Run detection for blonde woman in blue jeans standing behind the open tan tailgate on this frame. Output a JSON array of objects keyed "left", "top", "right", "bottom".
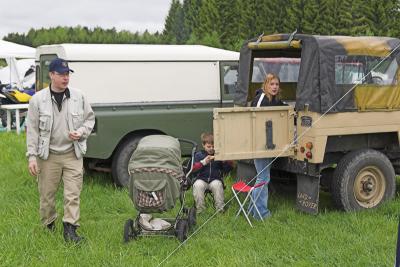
[{"left": 249, "top": 73, "right": 286, "bottom": 220}]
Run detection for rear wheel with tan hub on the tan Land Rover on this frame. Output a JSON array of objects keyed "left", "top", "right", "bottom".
[{"left": 332, "top": 149, "right": 396, "bottom": 211}]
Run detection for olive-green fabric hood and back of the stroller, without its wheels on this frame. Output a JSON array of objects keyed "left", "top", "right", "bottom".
[{"left": 129, "top": 135, "right": 184, "bottom": 212}]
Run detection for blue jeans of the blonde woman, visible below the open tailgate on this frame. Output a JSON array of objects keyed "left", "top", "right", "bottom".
[{"left": 249, "top": 158, "right": 272, "bottom": 220}]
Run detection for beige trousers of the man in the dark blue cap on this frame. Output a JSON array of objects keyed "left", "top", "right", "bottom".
[{"left": 38, "top": 150, "right": 83, "bottom": 225}]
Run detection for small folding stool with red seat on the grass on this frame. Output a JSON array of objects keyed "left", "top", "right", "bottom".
[{"left": 232, "top": 181, "right": 267, "bottom": 227}]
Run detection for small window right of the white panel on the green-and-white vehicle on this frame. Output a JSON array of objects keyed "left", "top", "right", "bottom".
[{"left": 221, "top": 62, "right": 239, "bottom": 100}]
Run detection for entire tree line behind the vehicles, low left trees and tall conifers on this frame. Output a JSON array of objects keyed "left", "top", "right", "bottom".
[{"left": 4, "top": 0, "right": 400, "bottom": 50}]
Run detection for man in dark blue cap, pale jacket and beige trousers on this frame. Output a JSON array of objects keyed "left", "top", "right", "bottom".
[{"left": 26, "top": 58, "right": 94, "bottom": 243}]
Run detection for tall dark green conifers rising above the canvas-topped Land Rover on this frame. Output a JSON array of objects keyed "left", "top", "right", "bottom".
[{"left": 163, "top": 0, "right": 400, "bottom": 50}]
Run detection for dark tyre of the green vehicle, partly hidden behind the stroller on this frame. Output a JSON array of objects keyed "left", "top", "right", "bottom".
[{"left": 111, "top": 136, "right": 143, "bottom": 187}]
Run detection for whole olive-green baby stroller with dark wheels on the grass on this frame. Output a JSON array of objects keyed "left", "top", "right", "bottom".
[{"left": 124, "top": 135, "right": 197, "bottom": 242}]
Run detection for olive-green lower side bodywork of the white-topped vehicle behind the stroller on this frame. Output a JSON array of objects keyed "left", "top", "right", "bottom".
[{"left": 86, "top": 102, "right": 221, "bottom": 159}]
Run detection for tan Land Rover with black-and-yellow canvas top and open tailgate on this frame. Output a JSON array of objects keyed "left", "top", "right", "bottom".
[{"left": 214, "top": 34, "right": 400, "bottom": 214}]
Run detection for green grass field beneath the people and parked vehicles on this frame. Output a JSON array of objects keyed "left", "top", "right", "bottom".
[{"left": 0, "top": 133, "right": 400, "bottom": 266}]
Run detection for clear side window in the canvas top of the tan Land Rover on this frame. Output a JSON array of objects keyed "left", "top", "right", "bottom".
[{"left": 335, "top": 55, "right": 398, "bottom": 85}]
